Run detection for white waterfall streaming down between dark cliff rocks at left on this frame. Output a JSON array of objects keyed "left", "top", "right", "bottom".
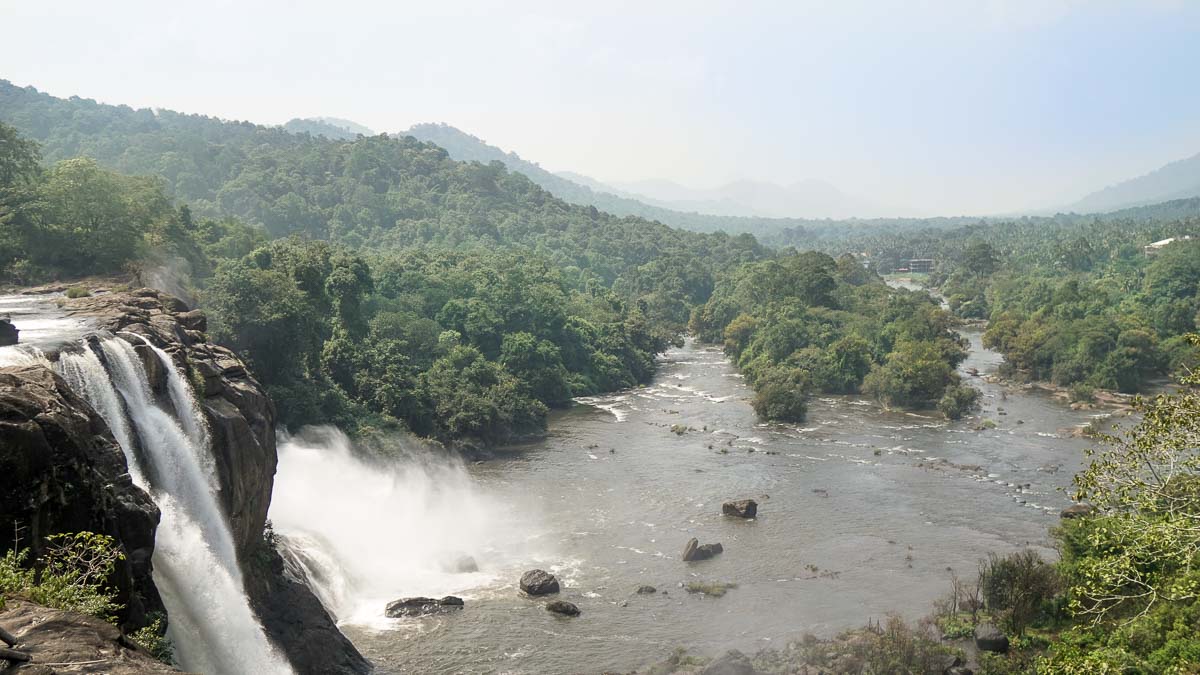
[{"left": 55, "top": 338, "right": 292, "bottom": 675}]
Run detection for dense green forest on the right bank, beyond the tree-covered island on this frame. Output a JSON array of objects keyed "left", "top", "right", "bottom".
[{"left": 825, "top": 211, "right": 1200, "bottom": 399}]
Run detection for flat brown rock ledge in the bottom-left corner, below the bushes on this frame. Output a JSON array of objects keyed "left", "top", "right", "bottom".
[{"left": 0, "top": 599, "right": 179, "bottom": 675}]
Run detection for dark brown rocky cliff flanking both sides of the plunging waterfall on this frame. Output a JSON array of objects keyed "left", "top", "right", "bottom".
[{"left": 0, "top": 288, "right": 370, "bottom": 674}]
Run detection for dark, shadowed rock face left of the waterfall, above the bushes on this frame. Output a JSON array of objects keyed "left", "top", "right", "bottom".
[{"left": 0, "top": 365, "right": 163, "bottom": 629}]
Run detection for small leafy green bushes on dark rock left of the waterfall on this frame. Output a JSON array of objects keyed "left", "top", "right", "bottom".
[{"left": 0, "top": 532, "right": 125, "bottom": 621}]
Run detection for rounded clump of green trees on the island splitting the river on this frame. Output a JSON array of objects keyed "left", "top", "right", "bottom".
[{"left": 691, "top": 252, "right": 978, "bottom": 420}]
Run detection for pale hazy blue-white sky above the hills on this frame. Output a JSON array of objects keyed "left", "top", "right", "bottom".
[{"left": 0, "top": 0, "right": 1200, "bottom": 215}]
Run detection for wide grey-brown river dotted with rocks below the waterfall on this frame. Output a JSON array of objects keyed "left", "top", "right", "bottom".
[{"left": 314, "top": 333, "right": 1108, "bottom": 673}]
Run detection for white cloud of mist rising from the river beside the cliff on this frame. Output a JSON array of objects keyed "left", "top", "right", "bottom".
[{"left": 270, "top": 426, "right": 546, "bottom": 625}]
